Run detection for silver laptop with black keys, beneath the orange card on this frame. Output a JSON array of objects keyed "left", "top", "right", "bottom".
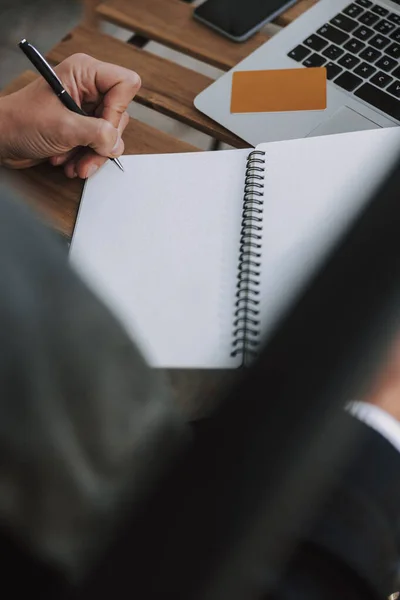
[{"left": 194, "top": 0, "right": 400, "bottom": 146}]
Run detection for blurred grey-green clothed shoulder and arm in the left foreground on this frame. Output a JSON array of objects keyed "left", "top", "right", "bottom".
[{"left": 0, "top": 183, "right": 186, "bottom": 597}]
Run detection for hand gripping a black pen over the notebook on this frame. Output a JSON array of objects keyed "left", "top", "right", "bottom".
[{"left": 0, "top": 54, "right": 141, "bottom": 178}]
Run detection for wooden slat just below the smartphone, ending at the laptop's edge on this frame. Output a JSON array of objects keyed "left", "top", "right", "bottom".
[{"left": 97, "top": 0, "right": 268, "bottom": 70}]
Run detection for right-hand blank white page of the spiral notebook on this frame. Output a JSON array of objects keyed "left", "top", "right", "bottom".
[{"left": 258, "top": 127, "right": 400, "bottom": 342}]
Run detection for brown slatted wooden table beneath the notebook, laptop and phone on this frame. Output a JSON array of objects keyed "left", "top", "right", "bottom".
[{"left": 2, "top": 0, "right": 317, "bottom": 416}]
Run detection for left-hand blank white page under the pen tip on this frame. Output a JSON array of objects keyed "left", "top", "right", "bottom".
[{"left": 71, "top": 150, "right": 248, "bottom": 368}]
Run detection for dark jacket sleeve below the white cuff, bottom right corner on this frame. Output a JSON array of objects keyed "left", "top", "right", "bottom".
[{"left": 271, "top": 417, "right": 400, "bottom": 600}]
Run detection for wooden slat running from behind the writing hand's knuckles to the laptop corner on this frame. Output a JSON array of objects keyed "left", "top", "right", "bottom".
[{"left": 47, "top": 27, "right": 249, "bottom": 148}]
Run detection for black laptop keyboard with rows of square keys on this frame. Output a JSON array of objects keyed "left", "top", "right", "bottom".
[{"left": 288, "top": 0, "right": 400, "bottom": 121}]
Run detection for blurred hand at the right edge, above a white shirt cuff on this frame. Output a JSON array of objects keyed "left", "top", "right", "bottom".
[{"left": 365, "top": 339, "right": 400, "bottom": 421}]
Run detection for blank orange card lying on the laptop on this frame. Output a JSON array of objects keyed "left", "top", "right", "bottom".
[{"left": 231, "top": 67, "right": 326, "bottom": 113}]
